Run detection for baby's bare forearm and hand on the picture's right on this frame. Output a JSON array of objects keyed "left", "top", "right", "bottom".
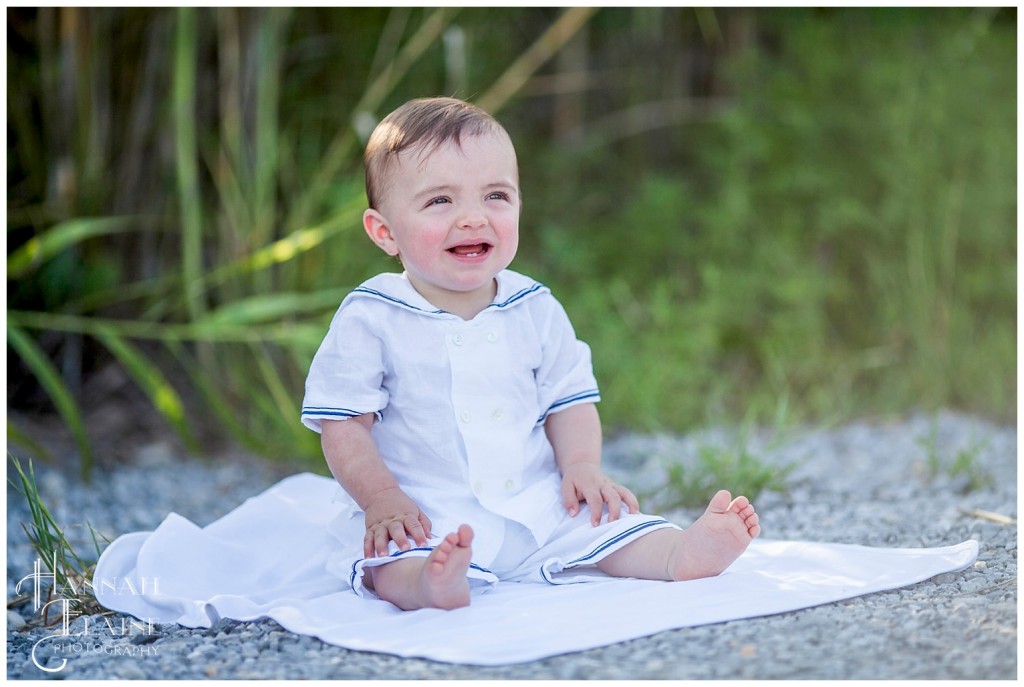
[{"left": 545, "top": 403, "right": 640, "bottom": 525}]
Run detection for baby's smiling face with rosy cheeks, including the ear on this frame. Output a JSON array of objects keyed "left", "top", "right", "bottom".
[{"left": 364, "top": 133, "right": 520, "bottom": 312}]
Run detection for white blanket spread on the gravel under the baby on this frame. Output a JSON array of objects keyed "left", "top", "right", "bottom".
[{"left": 93, "top": 474, "right": 978, "bottom": 665}]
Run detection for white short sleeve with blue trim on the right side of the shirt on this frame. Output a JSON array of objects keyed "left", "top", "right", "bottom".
[{"left": 537, "top": 296, "right": 601, "bottom": 423}]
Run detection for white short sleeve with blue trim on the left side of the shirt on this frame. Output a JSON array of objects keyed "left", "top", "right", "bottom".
[{"left": 302, "top": 301, "right": 388, "bottom": 432}]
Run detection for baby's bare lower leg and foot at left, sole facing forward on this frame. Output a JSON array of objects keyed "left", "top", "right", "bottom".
[{"left": 367, "top": 525, "right": 473, "bottom": 610}]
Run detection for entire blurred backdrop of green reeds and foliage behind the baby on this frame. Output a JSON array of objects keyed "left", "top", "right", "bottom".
[{"left": 7, "top": 8, "right": 1017, "bottom": 475}]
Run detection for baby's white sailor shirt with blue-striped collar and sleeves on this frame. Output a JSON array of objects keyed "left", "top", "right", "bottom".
[{"left": 302, "top": 270, "right": 599, "bottom": 559}]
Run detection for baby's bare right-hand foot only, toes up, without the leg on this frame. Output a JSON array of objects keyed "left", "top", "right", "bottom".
[{"left": 672, "top": 489, "right": 761, "bottom": 581}]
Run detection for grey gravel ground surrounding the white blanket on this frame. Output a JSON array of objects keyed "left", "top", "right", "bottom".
[{"left": 7, "top": 413, "right": 1017, "bottom": 680}]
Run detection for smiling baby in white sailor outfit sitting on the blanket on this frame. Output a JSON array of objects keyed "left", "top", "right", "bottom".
[{"left": 302, "top": 98, "right": 761, "bottom": 609}]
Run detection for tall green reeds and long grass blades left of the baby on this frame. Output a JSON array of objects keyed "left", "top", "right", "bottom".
[{"left": 7, "top": 8, "right": 595, "bottom": 475}]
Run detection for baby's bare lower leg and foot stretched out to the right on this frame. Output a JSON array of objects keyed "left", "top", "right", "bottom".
[{"left": 597, "top": 489, "right": 761, "bottom": 581}]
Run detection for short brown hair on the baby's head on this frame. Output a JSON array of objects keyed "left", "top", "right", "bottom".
[{"left": 362, "top": 97, "right": 508, "bottom": 209}]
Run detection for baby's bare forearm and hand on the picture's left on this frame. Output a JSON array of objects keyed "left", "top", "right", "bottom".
[{"left": 321, "top": 413, "right": 430, "bottom": 558}]
